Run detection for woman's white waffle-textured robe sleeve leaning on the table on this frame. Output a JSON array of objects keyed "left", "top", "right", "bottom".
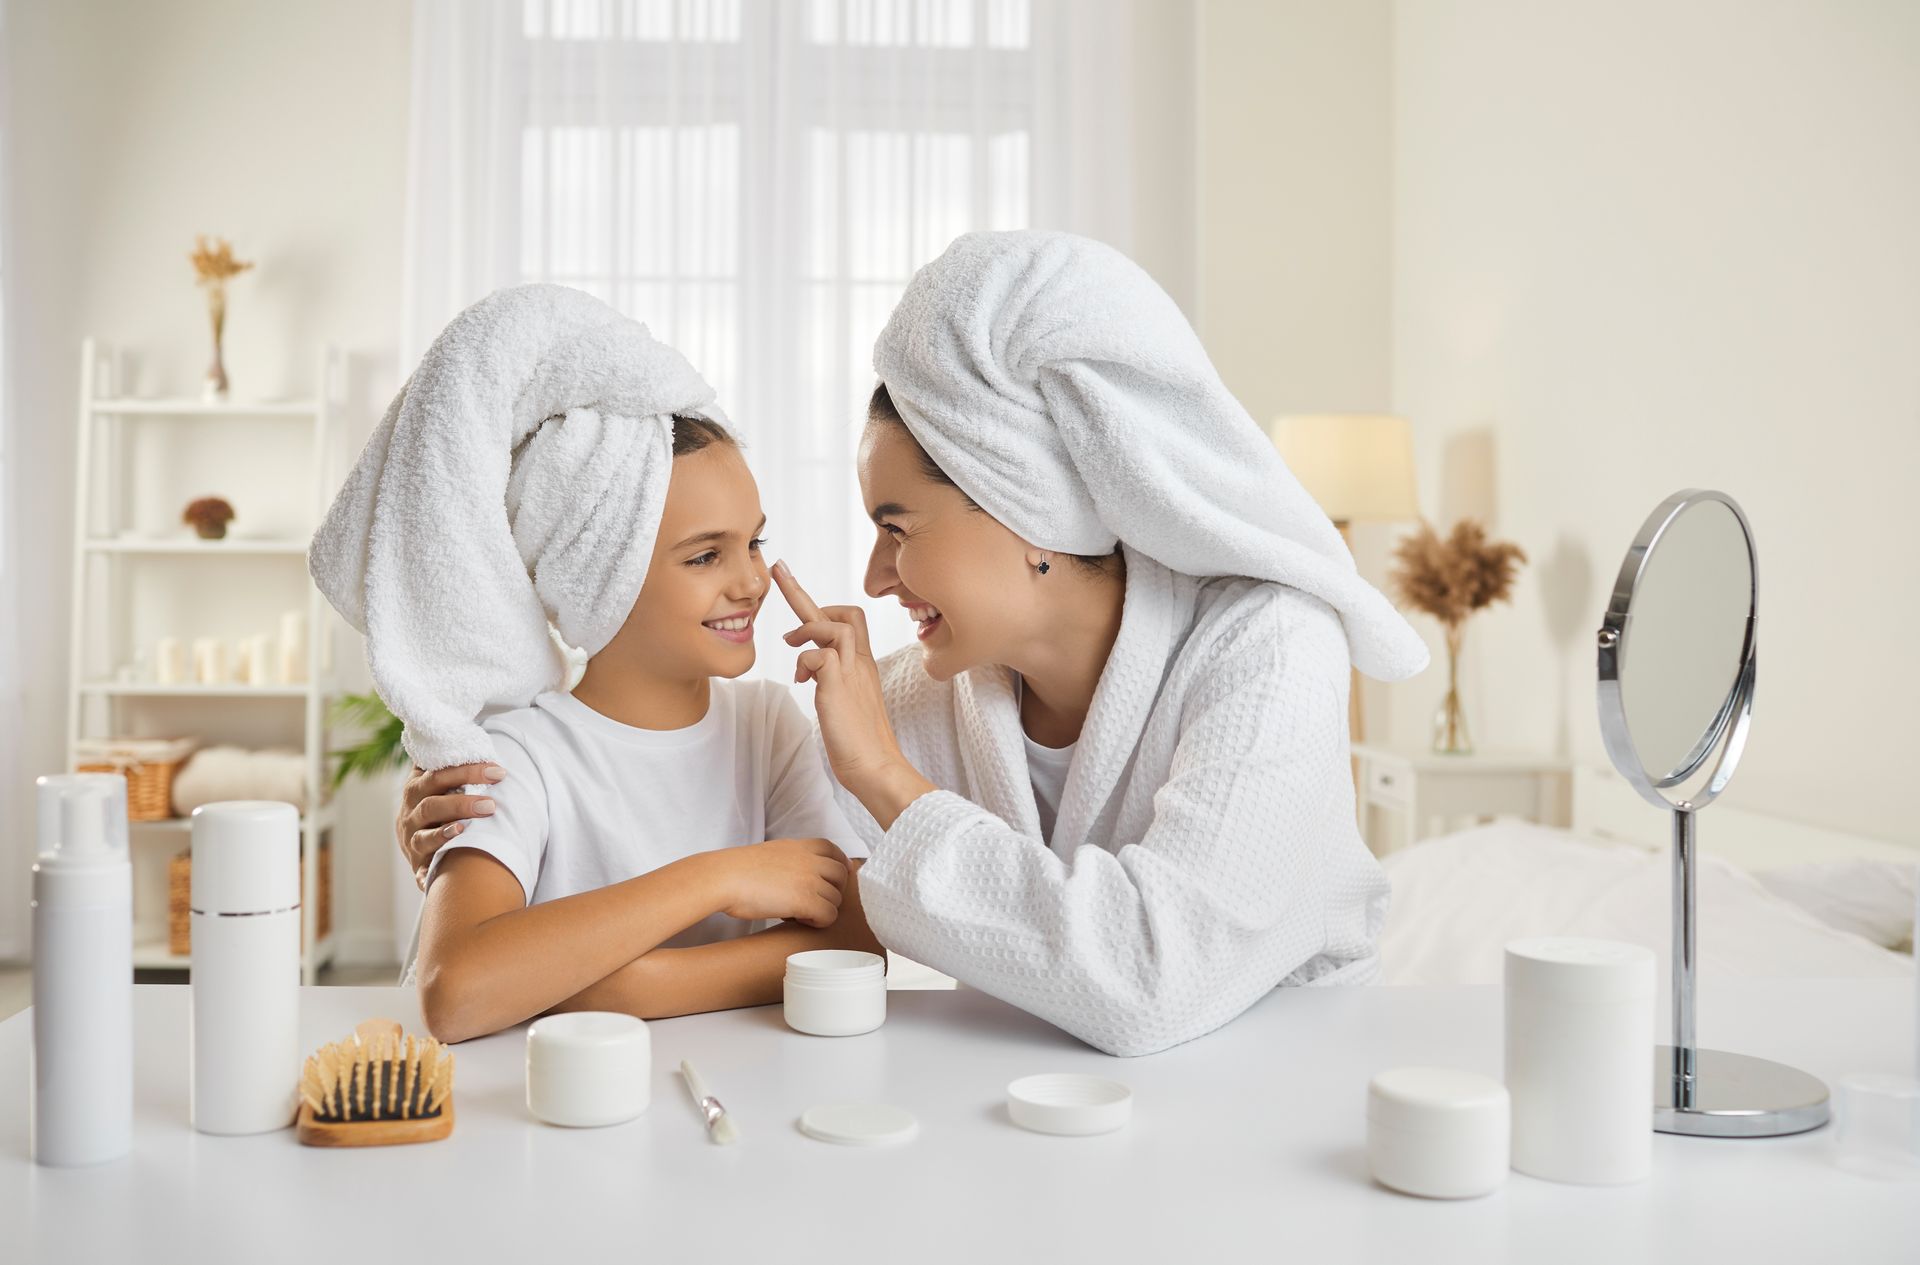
[{"left": 856, "top": 603, "right": 1386, "bottom": 1056}]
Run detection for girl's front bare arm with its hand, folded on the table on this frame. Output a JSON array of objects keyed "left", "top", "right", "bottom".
[{"left": 419, "top": 839, "right": 847, "bottom": 1040}]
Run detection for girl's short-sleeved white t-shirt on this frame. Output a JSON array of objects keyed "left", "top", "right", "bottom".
[{"left": 426, "top": 680, "right": 866, "bottom": 946}]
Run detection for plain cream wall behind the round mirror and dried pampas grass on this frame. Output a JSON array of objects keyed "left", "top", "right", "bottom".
[{"left": 1392, "top": 0, "right": 1920, "bottom": 841}]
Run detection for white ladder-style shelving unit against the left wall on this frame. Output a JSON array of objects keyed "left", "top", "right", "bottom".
[{"left": 67, "top": 340, "right": 342, "bottom": 985}]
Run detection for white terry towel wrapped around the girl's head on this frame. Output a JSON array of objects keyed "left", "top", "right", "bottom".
[{"left": 307, "top": 284, "right": 726, "bottom": 768}]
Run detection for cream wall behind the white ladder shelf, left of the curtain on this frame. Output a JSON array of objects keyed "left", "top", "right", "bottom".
[{"left": 0, "top": 0, "right": 411, "bottom": 958}]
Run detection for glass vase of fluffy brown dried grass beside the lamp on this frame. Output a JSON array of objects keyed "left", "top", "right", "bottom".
[{"left": 1390, "top": 518, "right": 1526, "bottom": 754}]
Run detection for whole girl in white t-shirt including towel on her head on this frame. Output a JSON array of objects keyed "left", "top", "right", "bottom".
[{"left": 311, "top": 286, "right": 877, "bottom": 1040}]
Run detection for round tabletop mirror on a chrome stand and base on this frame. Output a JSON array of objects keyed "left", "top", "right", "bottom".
[{"left": 1599, "top": 489, "right": 1828, "bottom": 1138}]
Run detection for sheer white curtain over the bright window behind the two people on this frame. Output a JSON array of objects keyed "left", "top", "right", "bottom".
[{"left": 401, "top": 0, "right": 1131, "bottom": 678}]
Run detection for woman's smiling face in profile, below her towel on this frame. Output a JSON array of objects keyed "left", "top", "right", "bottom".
[{"left": 860, "top": 418, "right": 1031, "bottom": 681}]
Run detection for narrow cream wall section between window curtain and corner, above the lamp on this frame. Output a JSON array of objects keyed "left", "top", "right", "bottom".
[{"left": 1194, "top": 0, "right": 1392, "bottom": 422}]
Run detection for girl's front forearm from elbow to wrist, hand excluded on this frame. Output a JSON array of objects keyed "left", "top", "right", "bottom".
[{"left": 419, "top": 848, "right": 726, "bottom": 1040}]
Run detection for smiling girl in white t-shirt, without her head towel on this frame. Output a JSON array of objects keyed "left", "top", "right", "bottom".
[{"left": 419, "top": 418, "right": 879, "bottom": 1040}]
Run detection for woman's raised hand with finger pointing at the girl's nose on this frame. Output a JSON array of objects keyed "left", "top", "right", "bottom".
[{"left": 774, "top": 562, "right": 933, "bottom": 829}]
